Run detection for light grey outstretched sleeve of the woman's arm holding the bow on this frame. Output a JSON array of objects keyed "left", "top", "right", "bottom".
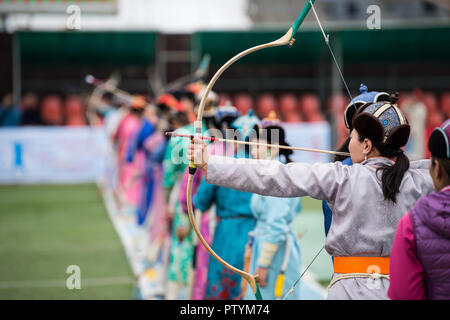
[{"left": 206, "top": 156, "right": 353, "bottom": 203}]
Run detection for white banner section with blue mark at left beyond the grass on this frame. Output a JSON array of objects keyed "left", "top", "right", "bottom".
[{"left": 0, "top": 127, "right": 108, "bottom": 184}]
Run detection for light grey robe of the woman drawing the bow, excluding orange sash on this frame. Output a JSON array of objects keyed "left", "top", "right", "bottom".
[{"left": 206, "top": 156, "right": 434, "bottom": 299}]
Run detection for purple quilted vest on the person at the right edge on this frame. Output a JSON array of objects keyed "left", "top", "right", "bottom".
[{"left": 410, "top": 187, "right": 450, "bottom": 300}]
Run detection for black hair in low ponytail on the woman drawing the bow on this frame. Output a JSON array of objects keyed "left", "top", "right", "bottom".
[{"left": 359, "top": 136, "right": 409, "bottom": 203}]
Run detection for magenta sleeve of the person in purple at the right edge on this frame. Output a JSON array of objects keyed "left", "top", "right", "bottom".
[{"left": 388, "top": 213, "right": 426, "bottom": 300}]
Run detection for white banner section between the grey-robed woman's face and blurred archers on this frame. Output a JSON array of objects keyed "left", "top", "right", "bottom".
[{"left": 283, "top": 121, "right": 332, "bottom": 163}]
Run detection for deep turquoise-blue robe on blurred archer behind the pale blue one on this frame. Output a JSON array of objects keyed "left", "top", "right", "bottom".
[{"left": 193, "top": 152, "right": 256, "bottom": 300}]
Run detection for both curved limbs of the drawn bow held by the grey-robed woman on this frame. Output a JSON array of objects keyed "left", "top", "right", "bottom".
[{"left": 186, "top": 0, "right": 315, "bottom": 300}]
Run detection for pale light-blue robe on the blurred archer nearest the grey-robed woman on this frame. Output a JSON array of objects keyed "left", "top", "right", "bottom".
[{"left": 244, "top": 194, "right": 301, "bottom": 300}]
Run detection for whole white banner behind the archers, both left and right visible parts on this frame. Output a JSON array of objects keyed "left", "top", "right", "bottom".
[{"left": 0, "top": 122, "right": 331, "bottom": 184}]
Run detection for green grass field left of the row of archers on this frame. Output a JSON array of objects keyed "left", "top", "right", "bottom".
[{"left": 0, "top": 184, "right": 134, "bottom": 299}]
